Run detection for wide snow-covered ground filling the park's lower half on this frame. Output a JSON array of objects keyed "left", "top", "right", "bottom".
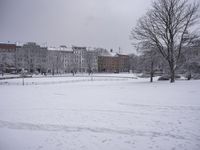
[{"left": 0, "top": 75, "right": 200, "bottom": 150}]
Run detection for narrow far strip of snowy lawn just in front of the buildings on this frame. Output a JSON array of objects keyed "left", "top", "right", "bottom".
[{"left": 0, "top": 73, "right": 136, "bottom": 85}]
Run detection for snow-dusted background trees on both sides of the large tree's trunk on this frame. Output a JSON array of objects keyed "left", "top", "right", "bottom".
[{"left": 130, "top": 40, "right": 200, "bottom": 82}]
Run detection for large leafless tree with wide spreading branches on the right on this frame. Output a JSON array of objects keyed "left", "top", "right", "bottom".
[{"left": 131, "top": 0, "right": 199, "bottom": 82}]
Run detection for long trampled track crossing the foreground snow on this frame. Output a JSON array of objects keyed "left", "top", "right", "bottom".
[{"left": 0, "top": 120, "right": 185, "bottom": 140}]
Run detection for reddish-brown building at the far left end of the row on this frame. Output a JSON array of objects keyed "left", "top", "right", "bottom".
[{"left": 0, "top": 43, "right": 16, "bottom": 73}]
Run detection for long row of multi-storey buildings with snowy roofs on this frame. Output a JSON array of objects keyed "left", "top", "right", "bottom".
[{"left": 0, "top": 42, "right": 129, "bottom": 74}]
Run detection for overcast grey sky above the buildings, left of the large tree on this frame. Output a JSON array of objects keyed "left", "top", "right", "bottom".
[{"left": 0, "top": 0, "right": 156, "bottom": 53}]
